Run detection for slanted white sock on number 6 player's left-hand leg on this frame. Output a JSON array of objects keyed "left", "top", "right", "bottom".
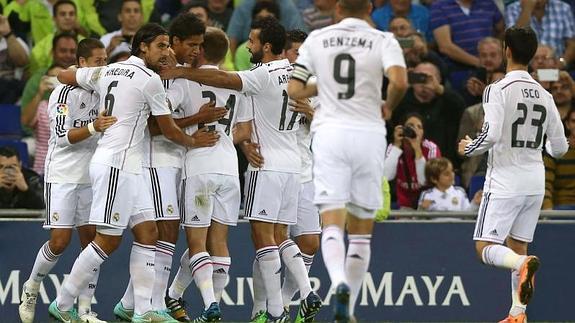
[{"left": 56, "top": 241, "right": 108, "bottom": 311}]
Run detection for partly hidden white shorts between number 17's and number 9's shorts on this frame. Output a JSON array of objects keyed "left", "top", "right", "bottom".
[{"left": 290, "top": 181, "right": 321, "bottom": 237}]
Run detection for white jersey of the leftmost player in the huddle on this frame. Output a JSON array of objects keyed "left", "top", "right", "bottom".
[{"left": 44, "top": 85, "right": 100, "bottom": 184}]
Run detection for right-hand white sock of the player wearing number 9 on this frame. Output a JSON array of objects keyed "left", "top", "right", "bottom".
[{"left": 345, "top": 234, "right": 371, "bottom": 315}]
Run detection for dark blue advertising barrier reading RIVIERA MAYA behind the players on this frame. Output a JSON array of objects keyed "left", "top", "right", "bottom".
[{"left": 0, "top": 212, "right": 575, "bottom": 322}]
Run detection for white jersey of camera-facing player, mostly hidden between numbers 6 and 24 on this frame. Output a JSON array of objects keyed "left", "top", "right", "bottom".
[{"left": 143, "top": 80, "right": 186, "bottom": 168}]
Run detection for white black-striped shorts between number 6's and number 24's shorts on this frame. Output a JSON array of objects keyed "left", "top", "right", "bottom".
[{"left": 144, "top": 167, "right": 181, "bottom": 221}]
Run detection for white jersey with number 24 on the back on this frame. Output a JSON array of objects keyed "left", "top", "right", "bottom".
[{"left": 168, "top": 65, "right": 252, "bottom": 178}]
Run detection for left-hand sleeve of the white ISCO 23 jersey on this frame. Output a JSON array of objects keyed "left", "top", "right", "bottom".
[{"left": 465, "top": 84, "right": 505, "bottom": 157}]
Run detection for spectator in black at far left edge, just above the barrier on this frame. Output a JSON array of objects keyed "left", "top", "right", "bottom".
[{"left": 0, "top": 147, "right": 44, "bottom": 209}]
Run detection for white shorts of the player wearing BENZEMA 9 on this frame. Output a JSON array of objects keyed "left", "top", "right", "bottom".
[{"left": 312, "top": 126, "right": 386, "bottom": 216}]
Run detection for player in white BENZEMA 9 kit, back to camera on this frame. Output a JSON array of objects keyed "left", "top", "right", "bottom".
[{"left": 288, "top": 0, "right": 407, "bottom": 322}]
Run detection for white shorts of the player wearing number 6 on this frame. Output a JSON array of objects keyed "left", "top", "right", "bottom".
[{"left": 90, "top": 163, "right": 154, "bottom": 229}]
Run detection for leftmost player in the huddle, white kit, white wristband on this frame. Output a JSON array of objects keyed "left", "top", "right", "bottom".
[{"left": 18, "top": 39, "right": 112, "bottom": 323}]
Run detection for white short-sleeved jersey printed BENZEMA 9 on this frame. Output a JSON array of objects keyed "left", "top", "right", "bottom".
[{"left": 293, "top": 18, "right": 405, "bottom": 132}]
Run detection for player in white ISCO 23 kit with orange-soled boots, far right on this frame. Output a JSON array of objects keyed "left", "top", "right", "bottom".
[{"left": 459, "top": 27, "right": 569, "bottom": 323}]
